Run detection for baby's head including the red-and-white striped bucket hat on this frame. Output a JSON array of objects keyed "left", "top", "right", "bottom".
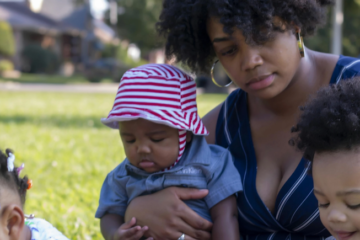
[{"left": 102, "top": 64, "right": 208, "bottom": 172}]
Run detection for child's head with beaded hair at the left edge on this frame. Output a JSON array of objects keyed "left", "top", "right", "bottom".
[{"left": 0, "top": 149, "right": 28, "bottom": 240}]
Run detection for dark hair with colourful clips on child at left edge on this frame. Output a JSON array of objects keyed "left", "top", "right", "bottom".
[{"left": 0, "top": 149, "right": 28, "bottom": 206}]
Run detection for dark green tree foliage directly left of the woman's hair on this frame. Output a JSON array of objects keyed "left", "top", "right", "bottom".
[{"left": 112, "top": 0, "right": 162, "bottom": 55}]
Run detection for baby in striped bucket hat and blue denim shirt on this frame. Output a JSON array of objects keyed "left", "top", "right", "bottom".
[{"left": 95, "top": 64, "right": 242, "bottom": 240}]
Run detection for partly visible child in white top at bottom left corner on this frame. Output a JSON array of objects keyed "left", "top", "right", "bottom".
[{"left": 0, "top": 149, "right": 68, "bottom": 240}]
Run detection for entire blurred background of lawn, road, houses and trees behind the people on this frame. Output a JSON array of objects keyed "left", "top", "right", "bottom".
[{"left": 0, "top": 0, "right": 360, "bottom": 240}]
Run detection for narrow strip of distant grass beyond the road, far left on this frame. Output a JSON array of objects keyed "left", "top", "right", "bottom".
[{"left": 0, "top": 73, "right": 89, "bottom": 84}]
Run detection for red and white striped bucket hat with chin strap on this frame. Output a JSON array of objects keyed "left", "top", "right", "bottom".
[{"left": 101, "top": 64, "right": 208, "bottom": 170}]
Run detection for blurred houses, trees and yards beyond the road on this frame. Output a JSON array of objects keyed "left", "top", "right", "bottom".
[{"left": 0, "top": 0, "right": 360, "bottom": 90}]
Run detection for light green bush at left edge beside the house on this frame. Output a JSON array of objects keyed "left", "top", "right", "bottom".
[{"left": 0, "top": 21, "right": 15, "bottom": 56}]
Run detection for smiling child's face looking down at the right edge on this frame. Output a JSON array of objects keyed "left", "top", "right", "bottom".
[{"left": 313, "top": 150, "right": 360, "bottom": 240}]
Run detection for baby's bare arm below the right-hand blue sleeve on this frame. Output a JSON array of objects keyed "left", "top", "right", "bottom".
[{"left": 210, "top": 195, "right": 240, "bottom": 240}]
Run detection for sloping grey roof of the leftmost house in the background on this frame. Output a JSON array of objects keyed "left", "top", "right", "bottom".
[{"left": 0, "top": 2, "right": 79, "bottom": 34}]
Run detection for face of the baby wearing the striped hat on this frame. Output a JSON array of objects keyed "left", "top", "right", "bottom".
[{"left": 119, "top": 119, "right": 179, "bottom": 173}]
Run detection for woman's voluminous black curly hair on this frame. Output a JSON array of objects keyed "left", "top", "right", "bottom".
[{"left": 157, "top": 0, "right": 334, "bottom": 72}]
